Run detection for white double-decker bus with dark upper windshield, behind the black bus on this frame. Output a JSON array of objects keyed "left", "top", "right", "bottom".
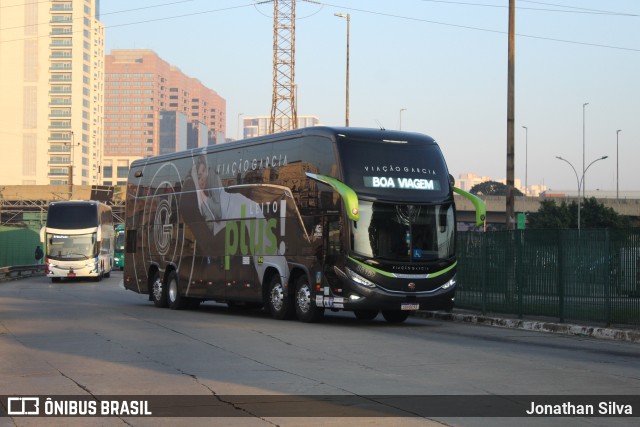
[{"left": 40, "top": 201, "right": 115, "bottom": 282}]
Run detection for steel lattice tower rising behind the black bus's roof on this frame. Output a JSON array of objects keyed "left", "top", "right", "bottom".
[{"left": 269, "top": 0, "right": 298, "bottom": 133}]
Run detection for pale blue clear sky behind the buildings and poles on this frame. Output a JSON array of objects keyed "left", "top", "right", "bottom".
[{"left": 100, "top": 0, "right": 640, "bottom": 192}]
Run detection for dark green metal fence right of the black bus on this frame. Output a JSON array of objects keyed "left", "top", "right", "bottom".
[{"left": 456, "top": 229, "right": 640, "bottom": 326}]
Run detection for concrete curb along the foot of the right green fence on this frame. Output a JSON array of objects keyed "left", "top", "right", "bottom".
[{"left": 414, "top": 311, "right": 640, "bottom": 342}]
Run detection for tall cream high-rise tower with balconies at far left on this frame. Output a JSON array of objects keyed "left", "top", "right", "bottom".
[{"left": 0, "top": 0, "right": 104, "bottom": 185}]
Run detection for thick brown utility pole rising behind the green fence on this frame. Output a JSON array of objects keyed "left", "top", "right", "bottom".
[{"left": 505, "top": 0, "right": 516, "bottom": 230}]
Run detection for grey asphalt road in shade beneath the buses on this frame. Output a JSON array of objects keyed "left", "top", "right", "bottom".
[{"left": 0, "top": 272, "right": 640, "bottom": 426}]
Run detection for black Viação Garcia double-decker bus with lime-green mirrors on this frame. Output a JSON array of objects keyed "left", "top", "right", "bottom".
[{"left": 124, "top": 127, "right": 484, "bottom": 322}]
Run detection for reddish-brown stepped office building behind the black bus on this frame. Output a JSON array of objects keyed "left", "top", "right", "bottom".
[{"left": 103, "top": 49, "right": 226, "bottom": 185}]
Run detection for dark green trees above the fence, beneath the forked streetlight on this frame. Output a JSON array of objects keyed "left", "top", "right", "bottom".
[{"left": 527, "top": 197, "right": 629, "bottom": 228}]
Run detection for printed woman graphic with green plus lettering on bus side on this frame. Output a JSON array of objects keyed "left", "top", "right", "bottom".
[{"left": 181, "top": 150, "right": 292, "bottom": 286}]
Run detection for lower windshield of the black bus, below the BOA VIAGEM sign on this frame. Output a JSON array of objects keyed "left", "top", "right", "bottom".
[{"left": 352, "top": 200, "right": 455, "bottom": 262}]
